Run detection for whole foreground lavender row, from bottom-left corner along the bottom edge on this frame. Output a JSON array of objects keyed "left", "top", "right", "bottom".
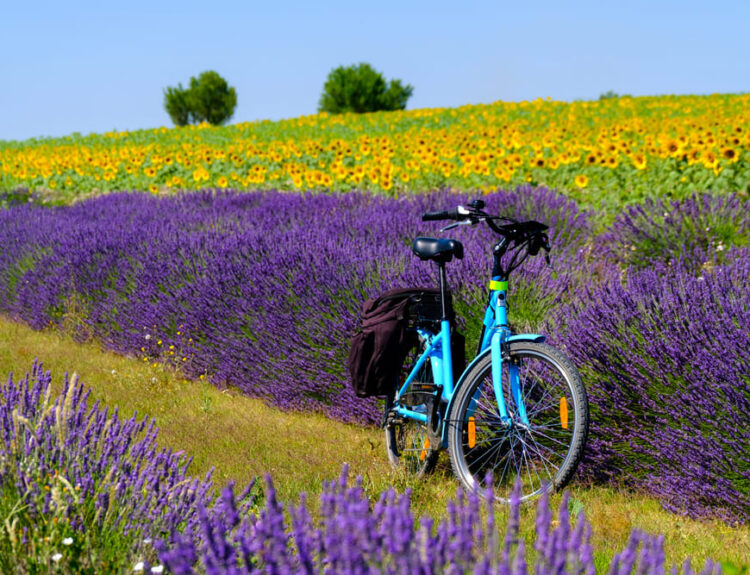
[{"left": 0, "top": 365, "right": 721, "bottom": 575}]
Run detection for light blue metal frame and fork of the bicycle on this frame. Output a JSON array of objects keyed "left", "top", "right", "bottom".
[{"left": 394, "top": 276, "right": 545, "bottom": 447}]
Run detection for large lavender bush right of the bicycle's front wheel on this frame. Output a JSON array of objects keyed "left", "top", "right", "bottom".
[{"left": 558, "top": 249, "right": 750, "bottom": 523}]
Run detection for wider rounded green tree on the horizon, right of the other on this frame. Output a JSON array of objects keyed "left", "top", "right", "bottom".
[{"left": 318, "top": 63, "right": 414, "bottom": 114}]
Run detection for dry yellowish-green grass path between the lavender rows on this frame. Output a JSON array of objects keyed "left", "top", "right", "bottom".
[{"left": 0, "top": 317, "right": 750, "bottom": 574}]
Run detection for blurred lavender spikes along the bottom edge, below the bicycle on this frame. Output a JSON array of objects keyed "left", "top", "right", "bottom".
[{"left": 156, "top": 469, "right": 721, "bottom": 575}]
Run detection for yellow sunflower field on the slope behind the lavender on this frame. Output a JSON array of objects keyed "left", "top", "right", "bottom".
[{"left": 0, "top": 94, "right": 750, "bottom": 205}]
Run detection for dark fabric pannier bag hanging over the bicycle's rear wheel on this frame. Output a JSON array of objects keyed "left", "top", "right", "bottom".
[{"left": 349, "top": 288, "right": 465, "bottom": 397}]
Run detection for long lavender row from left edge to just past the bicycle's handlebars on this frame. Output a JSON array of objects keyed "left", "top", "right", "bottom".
[{"left": 0, "top": 188, "right": 588, "bottom": 422}]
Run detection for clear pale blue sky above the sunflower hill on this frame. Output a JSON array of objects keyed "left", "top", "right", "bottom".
[{"left": 0, "top": 0, "right": 750, "bottom": 140}]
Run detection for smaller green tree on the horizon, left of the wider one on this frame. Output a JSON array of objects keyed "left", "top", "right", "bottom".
[{"left": 164, "top": 70, "right": 237, "bottom": 126}]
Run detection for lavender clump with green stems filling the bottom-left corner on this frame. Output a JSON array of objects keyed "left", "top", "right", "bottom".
[{"left": 0, "top": 364, "right": 229, "bottom": 573}]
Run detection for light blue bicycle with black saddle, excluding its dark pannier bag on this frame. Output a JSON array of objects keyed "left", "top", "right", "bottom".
[{"left": 383, "top": 200, "right": 589, "bottom": 501}]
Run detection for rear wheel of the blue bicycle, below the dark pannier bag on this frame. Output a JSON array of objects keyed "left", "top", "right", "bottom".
[{"left": 385, "top": 338, "right": 441, "bottom": 477}]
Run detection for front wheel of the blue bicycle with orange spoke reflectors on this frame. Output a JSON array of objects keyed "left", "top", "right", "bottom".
[{"left": 448, "top": 342, "right": 589, "bottom": 501}]
